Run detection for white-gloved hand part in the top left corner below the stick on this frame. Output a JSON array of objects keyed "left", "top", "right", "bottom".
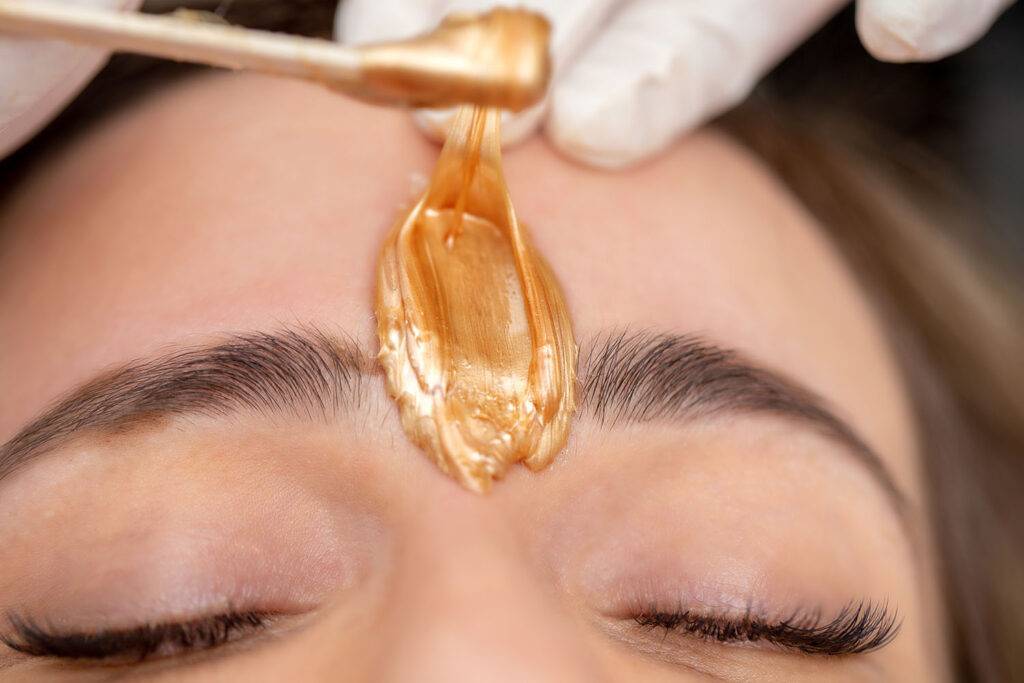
[{"left": 0, "top": 0, "right": 142, "bottom": 159}]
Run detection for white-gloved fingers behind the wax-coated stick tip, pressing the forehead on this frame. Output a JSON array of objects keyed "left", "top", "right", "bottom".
[{"left": 335, "top": 0, "right": 1013, "bottom": 168}]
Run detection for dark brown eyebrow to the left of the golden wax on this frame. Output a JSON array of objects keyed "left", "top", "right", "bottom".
[{"left": 0, "top": 329, "right": 370, "bottom": 480}]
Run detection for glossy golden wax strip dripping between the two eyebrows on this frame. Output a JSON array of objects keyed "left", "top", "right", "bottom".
[{"left": 377, "top": 106, "right": 577, "bottom": 493}]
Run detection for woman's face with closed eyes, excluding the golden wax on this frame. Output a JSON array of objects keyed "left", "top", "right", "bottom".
[{"left": 0, "top": 75, "right": 945, "bottom": 681}]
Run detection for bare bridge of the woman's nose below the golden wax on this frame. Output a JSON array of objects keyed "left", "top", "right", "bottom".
[{"left": 376, "top": 492, "right": 600, "bottom": 683}]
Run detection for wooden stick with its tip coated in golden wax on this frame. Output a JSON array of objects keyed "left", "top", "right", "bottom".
[{"left": 0, "top": 0, "right": 549, "bottom": 110}]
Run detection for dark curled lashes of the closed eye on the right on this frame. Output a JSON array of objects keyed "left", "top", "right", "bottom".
[{"left": 632, "top": 602, "right": 900, "bottom": 656}]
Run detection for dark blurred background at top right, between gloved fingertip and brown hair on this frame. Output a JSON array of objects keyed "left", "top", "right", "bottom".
[{"left": 763, "top": 2, "right": 1024, "bottom": 267}]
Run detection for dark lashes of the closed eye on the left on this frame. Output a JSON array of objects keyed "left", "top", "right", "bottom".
[{"left": 0, "top": 611, "right": 270, "bottom": 661}]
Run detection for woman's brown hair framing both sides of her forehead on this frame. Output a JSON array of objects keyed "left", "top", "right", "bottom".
[{"left": 0, "top": 0, "right": 1024, "bottom": 683}]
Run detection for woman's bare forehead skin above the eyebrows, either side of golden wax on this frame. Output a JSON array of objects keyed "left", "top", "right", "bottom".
[{"left": 0, "top": 75, "right": 912, "bottom": 491}]
